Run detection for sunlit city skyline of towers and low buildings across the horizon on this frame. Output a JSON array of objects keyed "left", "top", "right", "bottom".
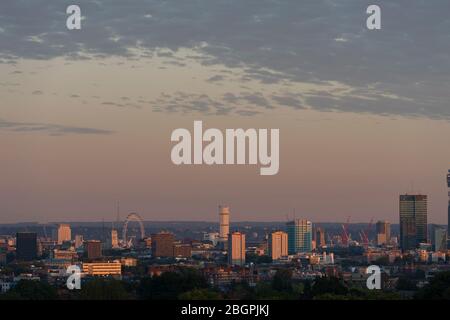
[{"left": 0, "top": 185, "right": 450, "bottom": 300}]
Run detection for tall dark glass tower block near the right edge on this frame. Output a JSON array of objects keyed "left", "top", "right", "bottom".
[{"left": 400, "top": 195, "right": 428, "bottom": 251}]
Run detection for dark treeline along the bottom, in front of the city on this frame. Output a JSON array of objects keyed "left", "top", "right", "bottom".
[{"left": 0, "top": 269, "right": 450, "bottom": 300}]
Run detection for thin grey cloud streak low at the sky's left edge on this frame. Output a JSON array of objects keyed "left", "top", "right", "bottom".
[{"left": 0, "top": 119, "right": 114, "bottom": 136}]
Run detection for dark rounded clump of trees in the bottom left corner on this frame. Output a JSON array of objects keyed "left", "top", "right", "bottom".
[{"left": 0, "top": 280, "right": 58, "bottom": 300}]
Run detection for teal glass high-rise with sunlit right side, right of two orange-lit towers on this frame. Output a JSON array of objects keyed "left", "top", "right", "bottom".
[{"left": 286, "top": 219, "right": 312, "bottom": 254}]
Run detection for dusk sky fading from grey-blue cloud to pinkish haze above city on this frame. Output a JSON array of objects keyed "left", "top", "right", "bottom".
[{"left": 0, "top": 0, "right": 450, "bottom": 224}]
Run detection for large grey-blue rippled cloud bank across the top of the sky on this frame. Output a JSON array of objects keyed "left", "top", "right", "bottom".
[{"left": 0, "top": 0, "right": 450, "bottom": 119}]
